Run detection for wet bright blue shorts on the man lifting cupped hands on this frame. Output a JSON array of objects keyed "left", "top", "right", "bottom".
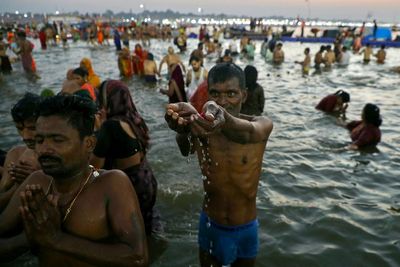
[{"left": 198, "top": 212, "right": 259, "bottom": 265}]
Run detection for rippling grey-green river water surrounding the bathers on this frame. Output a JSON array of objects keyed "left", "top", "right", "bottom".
[{"left": 0, "top": 36, "right": 400, "bottom": 267}]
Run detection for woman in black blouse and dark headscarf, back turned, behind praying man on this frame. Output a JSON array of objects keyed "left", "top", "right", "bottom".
[{"left": 91, "top": 80, "right": 157, "bottom": 234}]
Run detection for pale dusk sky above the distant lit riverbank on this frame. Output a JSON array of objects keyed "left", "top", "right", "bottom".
[{"left": 0, "top": 0, "right": 400, "bottom": 23}]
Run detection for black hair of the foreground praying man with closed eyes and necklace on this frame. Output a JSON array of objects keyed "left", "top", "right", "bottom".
[{"left": 39, "top": 95, "right": 96, "bottom": 140}]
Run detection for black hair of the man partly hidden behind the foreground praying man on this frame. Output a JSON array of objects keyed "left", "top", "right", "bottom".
[{"left": 11, "top": 93, "right": 41, "bottom": 122}]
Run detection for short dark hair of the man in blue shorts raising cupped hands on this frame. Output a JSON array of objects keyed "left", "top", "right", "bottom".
[{"left": 207, "top": 63, "right": 246, "bottom": 90}]
